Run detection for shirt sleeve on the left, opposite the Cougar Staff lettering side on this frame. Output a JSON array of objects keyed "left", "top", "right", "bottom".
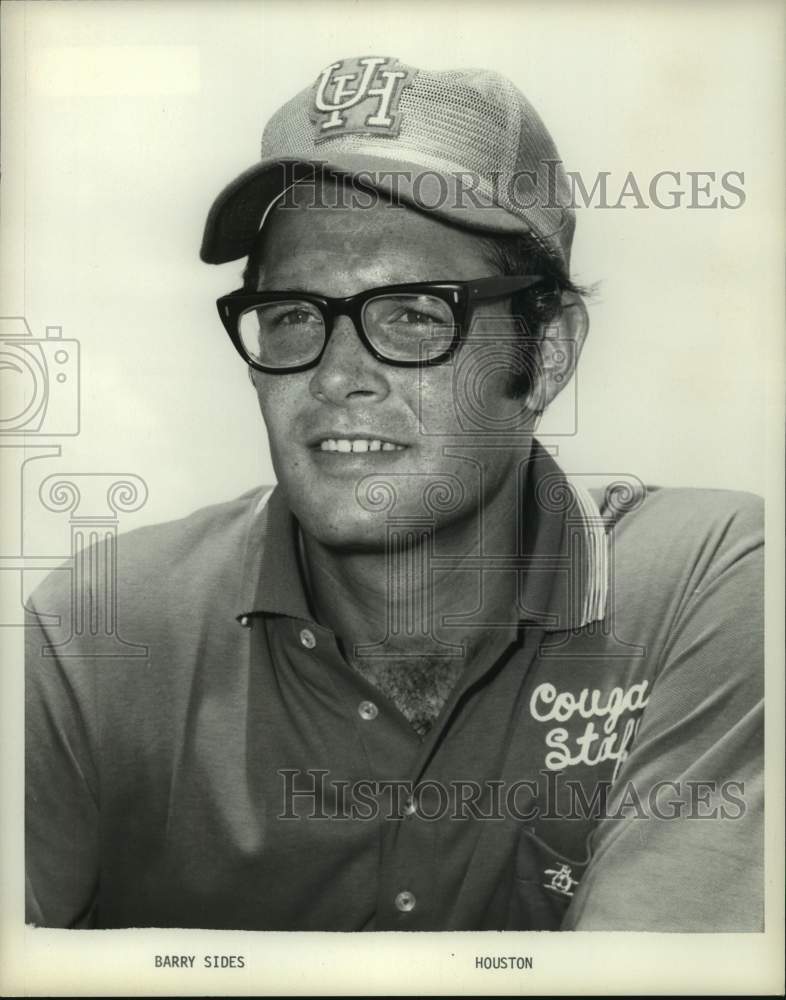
[{"left": 25, "top": 584, "right": 98, "bottom": 927}]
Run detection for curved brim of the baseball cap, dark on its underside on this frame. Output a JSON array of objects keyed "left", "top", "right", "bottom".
[{"left": 200, "top": 153, "right": 530, "bottom": 264}]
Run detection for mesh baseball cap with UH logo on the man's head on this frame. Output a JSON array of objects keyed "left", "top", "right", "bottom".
[{"left": 200, "top": 56, "right": 575, "bottom": 270}]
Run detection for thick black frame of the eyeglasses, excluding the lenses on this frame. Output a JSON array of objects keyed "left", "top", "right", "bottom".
[{"left": 216, "top": 274, "right": 556, "bottom": 375}]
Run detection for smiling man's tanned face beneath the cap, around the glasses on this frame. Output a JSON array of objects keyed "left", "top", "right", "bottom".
[{"left": 248, "top": 184, "right": 531, "bottom": 549}]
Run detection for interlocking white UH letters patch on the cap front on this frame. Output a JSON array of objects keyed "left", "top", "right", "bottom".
[{"left": 310, "top": 56, "right": 417, "bottom": 142}]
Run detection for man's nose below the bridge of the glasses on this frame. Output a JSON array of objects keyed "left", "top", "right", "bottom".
[{"left": 310, "top": 316, "right": 390, "bottom": 405}]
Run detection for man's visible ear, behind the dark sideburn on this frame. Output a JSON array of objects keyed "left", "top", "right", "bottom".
[{"left": 530, "top": 292, "right": 589, "bottom": 413}]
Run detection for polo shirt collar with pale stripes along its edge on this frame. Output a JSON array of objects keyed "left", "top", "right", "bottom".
[{"left": 236, "top": 441, "right": 608, "bottom": 631}]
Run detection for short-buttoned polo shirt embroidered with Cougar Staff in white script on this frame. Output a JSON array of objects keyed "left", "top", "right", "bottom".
[{"left": 26, "top": 448, "right": 763, "bottom": 931}]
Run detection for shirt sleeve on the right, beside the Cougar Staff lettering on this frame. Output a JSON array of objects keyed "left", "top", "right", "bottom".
[{"left": 562, "top": 498, "right": 764, "bottom": 932}]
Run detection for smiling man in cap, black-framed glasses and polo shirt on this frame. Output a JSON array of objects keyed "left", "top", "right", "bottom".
[{"left": 27, "top": 56, "right": 763, "bottom": 931}]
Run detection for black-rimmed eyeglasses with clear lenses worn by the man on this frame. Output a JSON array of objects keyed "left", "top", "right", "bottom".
[{"left": 216, "top": 275, "right": 546, "bottom": 374}]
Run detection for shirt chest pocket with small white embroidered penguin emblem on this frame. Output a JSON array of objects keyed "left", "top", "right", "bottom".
[{"left": 509, "top": 829, "right": 590, "bottom": 931}]
